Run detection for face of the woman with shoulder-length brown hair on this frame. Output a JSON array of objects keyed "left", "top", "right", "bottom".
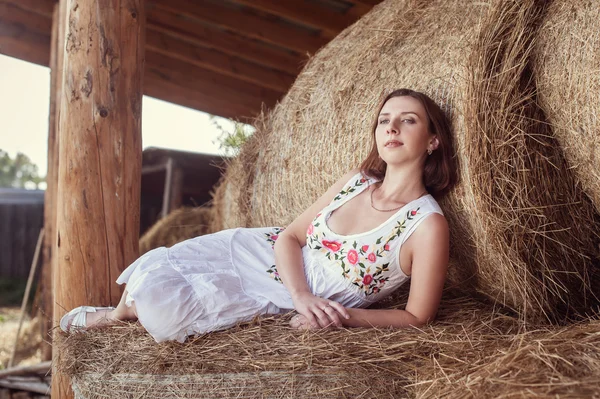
[{"left": 375, "top": 96, "right": 438, "bottom": 165}]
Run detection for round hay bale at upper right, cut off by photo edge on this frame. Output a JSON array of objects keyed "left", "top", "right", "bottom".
[{"left": 534, "top": 0, "right": 600, "bottom": 216}]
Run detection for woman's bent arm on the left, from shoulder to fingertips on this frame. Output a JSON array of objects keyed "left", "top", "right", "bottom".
[{"left": 274, "top": 168, "right": 360, "bottom": 328}]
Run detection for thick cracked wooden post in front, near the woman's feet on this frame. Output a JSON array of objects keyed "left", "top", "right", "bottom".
[{"left": 52, "top": 0, "right": 145, "bottom": 399}]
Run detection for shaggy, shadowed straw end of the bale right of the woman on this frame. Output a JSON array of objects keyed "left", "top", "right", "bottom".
[{"left": 459, "top": 0, "right": 600, "bottom": 323}]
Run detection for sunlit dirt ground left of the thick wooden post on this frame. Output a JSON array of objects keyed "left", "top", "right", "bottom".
[{"left": 0, "top": 307, "right": 42, "bottom": 370}]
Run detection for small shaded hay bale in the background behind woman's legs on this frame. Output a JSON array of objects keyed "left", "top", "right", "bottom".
[{"left": 140, "top": 206, "right": 212, "bottom": 255}]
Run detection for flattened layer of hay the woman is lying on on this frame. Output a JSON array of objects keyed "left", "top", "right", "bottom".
[{"left": 55, "top": 292, "right": 600, "bottom": 399}]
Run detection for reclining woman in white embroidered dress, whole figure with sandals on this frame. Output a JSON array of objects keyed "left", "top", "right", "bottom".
[{"left": 60, "top": 89, "right": 457, "bottom": 342}]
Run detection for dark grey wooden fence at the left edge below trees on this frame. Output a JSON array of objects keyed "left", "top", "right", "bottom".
[{"left": 0, "top": 188, "right": 44, "bottom": 280}]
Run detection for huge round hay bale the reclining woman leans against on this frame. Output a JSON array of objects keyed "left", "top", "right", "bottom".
[{"left": 249, "top": 0, "right": 600, "bottom": 322}]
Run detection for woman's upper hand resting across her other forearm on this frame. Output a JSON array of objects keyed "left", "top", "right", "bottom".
[{"left": 292, "top": 292, "right": 350, "bottom": 328}]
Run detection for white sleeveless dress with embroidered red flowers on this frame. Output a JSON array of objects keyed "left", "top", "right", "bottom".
[{"left": 117, "top": 173, "right": 443, "bottom": 342}]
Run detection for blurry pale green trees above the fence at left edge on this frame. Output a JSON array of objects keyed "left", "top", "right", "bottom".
[{"left": 0, "top": 149, "right": 45, "bottom": 188}]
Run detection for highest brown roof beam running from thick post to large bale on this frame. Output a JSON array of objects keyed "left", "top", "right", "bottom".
[{"left": 148, "top": 8, "right": 307, "bottom": 75}]
